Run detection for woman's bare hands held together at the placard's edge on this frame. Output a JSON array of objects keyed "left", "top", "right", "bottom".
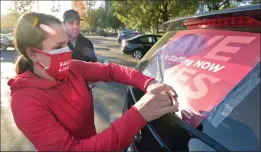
[{"left": 134, "top": 84, "right": 179, "bottom": 122}]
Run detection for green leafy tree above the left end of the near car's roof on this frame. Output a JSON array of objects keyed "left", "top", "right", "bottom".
[{"left": 112, "top": 0, "right": 198, "bottom": 33}]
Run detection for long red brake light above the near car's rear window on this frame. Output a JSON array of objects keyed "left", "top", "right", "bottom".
[{"left": 184, "top": 16, "right": 261, "bottom": 29}]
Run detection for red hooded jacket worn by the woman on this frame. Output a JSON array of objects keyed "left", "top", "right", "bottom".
[{"left": 8, "top": 60, "right": 152, "bottom": 151}]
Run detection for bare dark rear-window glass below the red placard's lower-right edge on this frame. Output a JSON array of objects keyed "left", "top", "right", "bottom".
[{"left": 199, "top": 68, "right": 260, "bottom": 151}]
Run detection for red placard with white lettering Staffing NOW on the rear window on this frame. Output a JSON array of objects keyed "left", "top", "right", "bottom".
[{"left": 145, "top": 30, "right": 260, "bottom": 127}]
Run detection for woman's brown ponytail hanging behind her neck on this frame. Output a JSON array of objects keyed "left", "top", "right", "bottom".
[{"left": 15, "top": 55, "right": 33, "bottom": 75}]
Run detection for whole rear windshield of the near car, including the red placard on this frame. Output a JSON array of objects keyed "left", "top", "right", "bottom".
[{"left": 138, "top": 29, "right": 260, "bottom": 151}]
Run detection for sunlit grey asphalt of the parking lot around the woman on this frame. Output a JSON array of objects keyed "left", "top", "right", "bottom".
[{"left": 1, "top": 36, "right": 137, "bottom": 151}]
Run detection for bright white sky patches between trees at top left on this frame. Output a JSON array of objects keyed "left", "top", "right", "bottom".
[{"left": 1, "top": 0, "right": 102, "bottom": 20}]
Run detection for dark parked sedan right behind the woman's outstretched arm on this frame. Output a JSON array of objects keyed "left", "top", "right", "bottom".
[{"left": 121, "top": 34, "right": 161, "bottom": 59}]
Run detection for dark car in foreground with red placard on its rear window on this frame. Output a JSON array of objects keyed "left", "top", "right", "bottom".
[{"left": 123, "top": 4, "right": 261, "bottom": 152}]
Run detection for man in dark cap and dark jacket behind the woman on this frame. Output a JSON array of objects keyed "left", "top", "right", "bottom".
[{"left": 63, "top": 10, "right": 97, "bottom": 62}]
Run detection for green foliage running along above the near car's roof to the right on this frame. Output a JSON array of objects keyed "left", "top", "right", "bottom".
[{"left": 112, "top": 0, "right": 251, "bottom": 33}]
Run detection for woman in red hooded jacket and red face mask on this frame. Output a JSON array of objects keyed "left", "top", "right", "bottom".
[{"left": 8, "top": 13, "right": 178, "bottom": 151}]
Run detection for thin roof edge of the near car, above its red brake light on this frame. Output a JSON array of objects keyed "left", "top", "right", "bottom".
[{"left": 160, "top": 4, "right": 260, "bottom": 30}]
